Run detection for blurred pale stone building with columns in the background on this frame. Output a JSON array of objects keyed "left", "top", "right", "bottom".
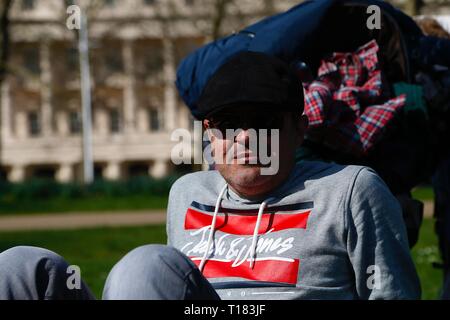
[{"left": 0, "top": 0, "right": 448, "bottom": 182}]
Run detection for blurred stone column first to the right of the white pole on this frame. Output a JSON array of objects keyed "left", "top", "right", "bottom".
[{"left": 122, "top": 40, "right": 136, "bottom": 134}]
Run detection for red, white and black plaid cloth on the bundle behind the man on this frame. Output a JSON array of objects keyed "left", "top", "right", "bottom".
[{"left": 303, "top": 40, "right": 406, "bottom": 156}]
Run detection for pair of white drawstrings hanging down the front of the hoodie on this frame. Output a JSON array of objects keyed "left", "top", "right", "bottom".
[{"left": 199, "top": 184, "right": 274, "bottom": 272}]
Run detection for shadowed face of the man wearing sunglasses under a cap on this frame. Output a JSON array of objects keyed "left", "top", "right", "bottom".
[{"left": 203, "top": 108, "right": 307, "bottom": 198}]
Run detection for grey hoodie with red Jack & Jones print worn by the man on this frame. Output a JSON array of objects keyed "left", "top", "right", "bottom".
[{"left": 167, "top": 161, "right": 420, "bottom": 299}]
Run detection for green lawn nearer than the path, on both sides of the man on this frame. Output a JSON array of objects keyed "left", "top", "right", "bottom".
[{"left": 0, "top": 219, "right": 442, "bottom": 299}]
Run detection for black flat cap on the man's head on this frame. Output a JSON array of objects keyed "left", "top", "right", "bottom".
[{"left": 197, "top": 51, "right": 304, "bottom": 119}]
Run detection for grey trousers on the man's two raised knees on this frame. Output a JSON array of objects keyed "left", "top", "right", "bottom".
[{"left": 0, "top": 245, "right": 219, "bottom": 300}]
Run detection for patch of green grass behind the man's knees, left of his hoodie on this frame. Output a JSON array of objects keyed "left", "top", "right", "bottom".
[{"left": 0, "top": 225, "right": 166, "bottom": 298}]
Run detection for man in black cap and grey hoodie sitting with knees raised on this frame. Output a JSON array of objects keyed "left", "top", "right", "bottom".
[{"left": 0, "top": 52, "right": 420, "bottom": 299}]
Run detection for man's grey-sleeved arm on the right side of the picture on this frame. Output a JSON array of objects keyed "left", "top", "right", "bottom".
[{"left": 346, "top": 168, "right": 421, "bottom": 299}]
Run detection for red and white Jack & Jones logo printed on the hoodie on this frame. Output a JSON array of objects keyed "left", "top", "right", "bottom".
[{"left": 182, "top": 202, "right": 313, "bottom": 286}]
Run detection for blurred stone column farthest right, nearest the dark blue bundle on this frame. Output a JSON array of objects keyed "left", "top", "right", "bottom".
[{"left": 163, "top": 38, "right": 177, "bottom": 131}]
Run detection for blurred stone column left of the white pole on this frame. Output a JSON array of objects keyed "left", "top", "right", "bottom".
[{"left": 40, "top": 41, "right": 52, "bottom": 137}]
